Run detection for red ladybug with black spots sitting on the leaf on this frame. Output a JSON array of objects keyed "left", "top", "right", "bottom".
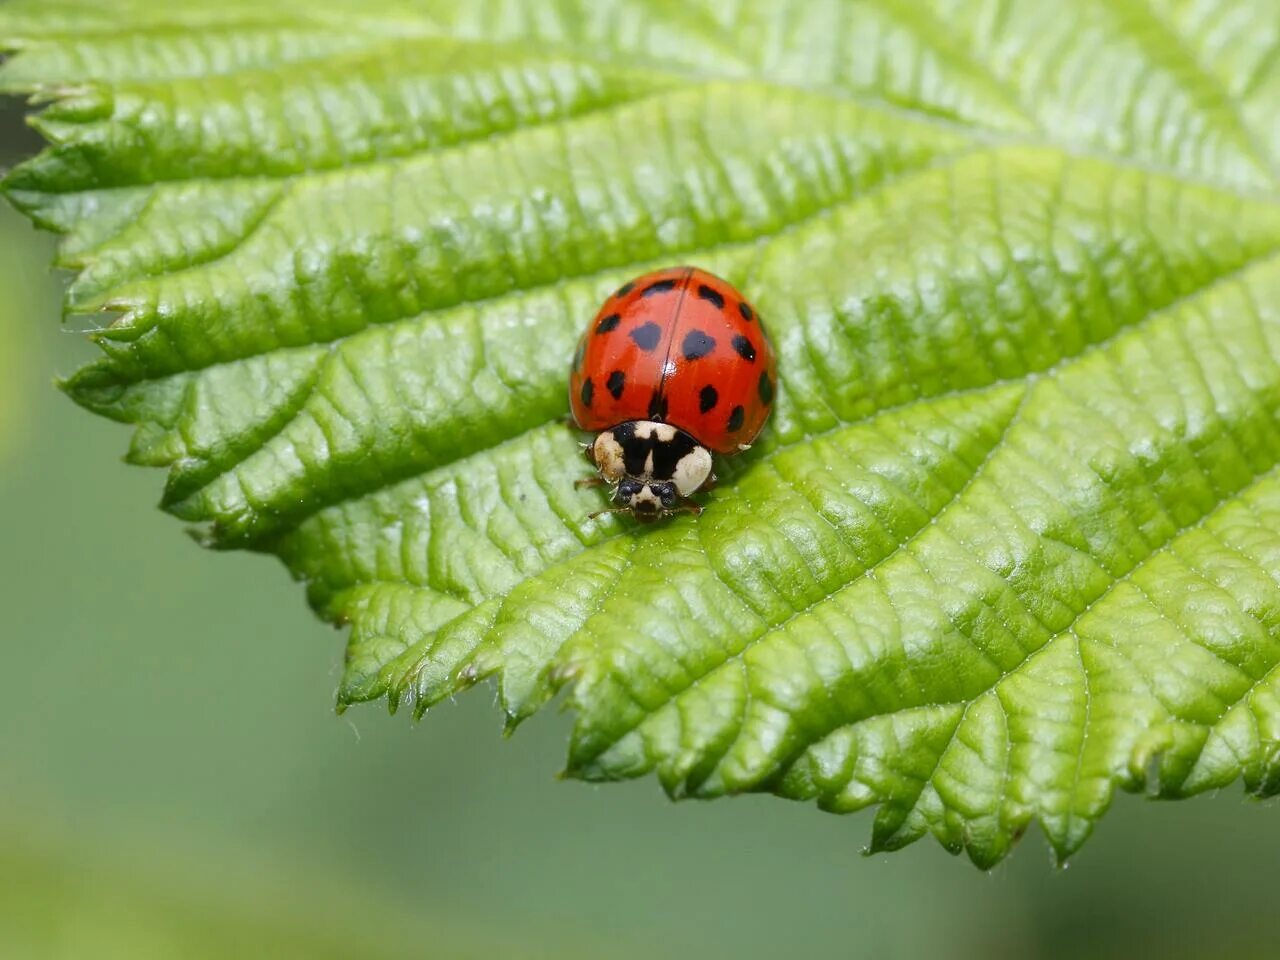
[{"left": 568, "top": 266, "right": 777, "bottom": 522}]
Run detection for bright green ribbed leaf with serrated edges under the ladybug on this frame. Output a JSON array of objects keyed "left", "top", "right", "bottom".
[{"left": 0, "top": 0, "right": 1280, "bottom": 865}]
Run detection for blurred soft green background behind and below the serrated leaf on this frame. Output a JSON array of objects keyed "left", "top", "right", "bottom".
[{"left": 0, "top": 104, "right": 1280, "bottom": 960}]
